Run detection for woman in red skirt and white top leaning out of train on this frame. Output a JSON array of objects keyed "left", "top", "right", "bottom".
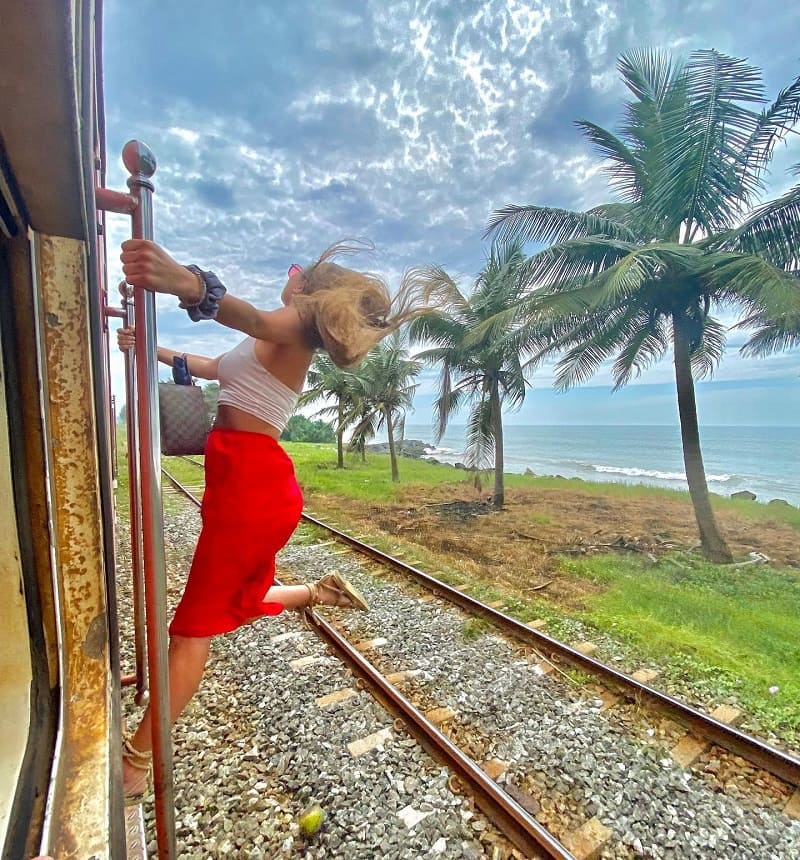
[{"left": 118, "top": 239, "right": 428, "bottom": 800}]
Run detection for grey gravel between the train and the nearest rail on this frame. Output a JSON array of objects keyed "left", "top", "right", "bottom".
[{"left": 118, "top": 504, "right": 521, "bottom": 860}]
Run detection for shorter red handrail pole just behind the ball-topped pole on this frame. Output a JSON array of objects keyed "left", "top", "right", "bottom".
[{"left": 119, "top": 281, "right": 148, "bottom": 705}]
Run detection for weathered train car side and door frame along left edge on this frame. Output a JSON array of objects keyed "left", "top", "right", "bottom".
[{"left": 0, "top": 0, "right": 126, "bottom": 860}]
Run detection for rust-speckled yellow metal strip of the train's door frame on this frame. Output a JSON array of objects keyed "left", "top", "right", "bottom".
[{"left": 34, "top": 236, "right": 112, "bottom": 860}]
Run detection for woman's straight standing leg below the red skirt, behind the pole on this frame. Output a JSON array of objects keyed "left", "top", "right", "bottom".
[{"left": 122, "top": 636, "right": 211, "bottom": 793}]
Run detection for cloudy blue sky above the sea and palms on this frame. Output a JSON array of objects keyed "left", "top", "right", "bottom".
[{"left": 104, "top": 0, "right": 800, "bottom": 424}]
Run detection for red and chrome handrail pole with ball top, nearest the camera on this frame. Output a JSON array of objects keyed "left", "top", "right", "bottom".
[{"left": 122, "top": 140, "right": 178, "bottom": 860}]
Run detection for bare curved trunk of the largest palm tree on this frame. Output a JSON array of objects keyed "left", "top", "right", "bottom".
[{"left": 672, "top": 314, "right": 733, "bottom": 564}]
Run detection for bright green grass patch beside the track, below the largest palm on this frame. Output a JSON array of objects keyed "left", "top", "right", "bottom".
[{"left": 562, "top": 556, "right": 800, "bottom": 732}]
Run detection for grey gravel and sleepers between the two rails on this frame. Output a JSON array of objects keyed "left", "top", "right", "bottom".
[{"left": 276, "top": 546, "right": 800, "bottom": 860}]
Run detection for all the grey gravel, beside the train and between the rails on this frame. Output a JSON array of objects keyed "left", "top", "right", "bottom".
[{"left": 120, "top": 504, "right": 800, "bottom": 860}]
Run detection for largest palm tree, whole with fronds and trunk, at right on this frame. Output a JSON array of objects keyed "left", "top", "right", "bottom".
[{"left": 487, "top": 50, "right": 800, "bottom": 562}]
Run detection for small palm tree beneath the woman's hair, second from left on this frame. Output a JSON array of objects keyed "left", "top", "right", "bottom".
[{"left": 347, "top": 330, "right": 422, "bottom": 481}]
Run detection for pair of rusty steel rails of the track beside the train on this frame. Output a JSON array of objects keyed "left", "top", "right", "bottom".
[{"left": 161, "top": 466, "right": 800, "bottom": 857}]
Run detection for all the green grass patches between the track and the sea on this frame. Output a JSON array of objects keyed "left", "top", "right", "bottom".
[{"left": 118, "top": 435, "right": 800, "bottom": 740}]
